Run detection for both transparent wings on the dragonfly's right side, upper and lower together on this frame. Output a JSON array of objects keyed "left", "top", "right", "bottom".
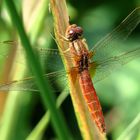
[{"left": 91, "top": 8, "right": 140, "bottom": 82}]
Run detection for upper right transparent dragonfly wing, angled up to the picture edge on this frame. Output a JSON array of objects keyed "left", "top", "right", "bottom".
[{"left": 91, "top": 7, "right": 140, "bottom": 61}]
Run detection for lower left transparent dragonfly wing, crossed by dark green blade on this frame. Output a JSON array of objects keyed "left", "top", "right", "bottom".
[{"left": 0, "top": 70, "right": 67, "bottom": 92}]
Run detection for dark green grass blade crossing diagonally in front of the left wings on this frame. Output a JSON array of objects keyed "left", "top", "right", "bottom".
[{"left": 5, "top": 0, "right": 71, "bottom": 140}]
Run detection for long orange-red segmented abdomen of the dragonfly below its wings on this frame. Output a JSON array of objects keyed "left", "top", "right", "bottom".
[{"left": 79, "top": 70, "right": 106, "bottom": 133}]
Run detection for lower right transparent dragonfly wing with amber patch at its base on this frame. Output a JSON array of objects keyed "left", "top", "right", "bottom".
[{"left": 91, "top": 47, "right": 140, "bottom": 83}]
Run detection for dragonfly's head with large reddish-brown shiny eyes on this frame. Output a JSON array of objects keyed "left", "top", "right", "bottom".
[{"left": 65, "top": 24, "right": 83, "bottom": 42}]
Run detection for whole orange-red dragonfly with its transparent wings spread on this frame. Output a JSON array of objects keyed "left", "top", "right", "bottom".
[{"left": 0, "top": 8, "right": 140, "bottom": 133}]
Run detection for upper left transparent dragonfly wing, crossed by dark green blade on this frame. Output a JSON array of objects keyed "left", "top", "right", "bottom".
[{"left": 0, "top": 40, "right": 72, "bottom": 71}]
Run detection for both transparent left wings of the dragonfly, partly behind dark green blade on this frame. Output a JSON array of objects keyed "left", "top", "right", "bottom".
[{"left": 0, "top": 41, "right": 67, "bottom": 91}]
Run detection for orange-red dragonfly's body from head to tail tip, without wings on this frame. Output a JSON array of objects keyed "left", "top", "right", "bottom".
[{"left": 64, "top": 24, "right": 106, "bottom": 133}]
